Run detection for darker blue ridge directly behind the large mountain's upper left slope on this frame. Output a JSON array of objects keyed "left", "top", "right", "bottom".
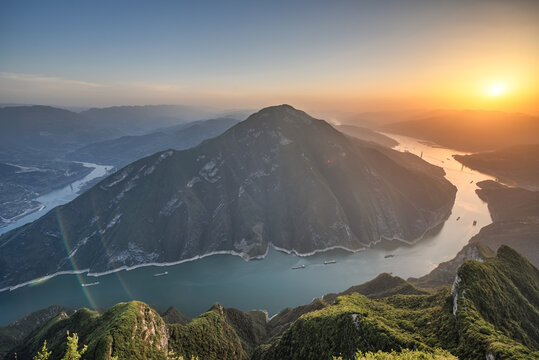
[{"left": 67, "top": 118, "right": 238, "bottom": 167}]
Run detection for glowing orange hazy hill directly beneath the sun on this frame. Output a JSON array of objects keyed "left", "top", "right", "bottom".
[{"left": 381, "top": 110, "right": 539, "bottom": 152}]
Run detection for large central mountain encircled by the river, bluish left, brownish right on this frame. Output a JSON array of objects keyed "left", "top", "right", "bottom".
[{"left": 0, "top": 105, "right": 456, "bottom": 288}]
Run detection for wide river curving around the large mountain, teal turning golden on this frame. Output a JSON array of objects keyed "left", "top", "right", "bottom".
[{"left": 0, "top": 134, "right": 492, "bottom": 325}]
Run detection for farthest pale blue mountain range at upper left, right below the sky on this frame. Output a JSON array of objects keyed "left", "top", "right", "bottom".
[{"left": 0, "top": 105, "right": 243, "bottom": 164}]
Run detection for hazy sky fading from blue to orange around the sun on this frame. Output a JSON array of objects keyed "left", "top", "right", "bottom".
[{"left": 0, "top": 0, "right": 539, "bottom": 113}]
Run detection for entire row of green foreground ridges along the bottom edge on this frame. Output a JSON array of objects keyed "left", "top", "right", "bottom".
[{"left": 0, "top": 246, "right": 539, "bottom": 360}]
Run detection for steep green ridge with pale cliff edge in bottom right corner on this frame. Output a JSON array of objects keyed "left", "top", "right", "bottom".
[{"left": 452, "top": 246, "right": 539, "bottom": 359}]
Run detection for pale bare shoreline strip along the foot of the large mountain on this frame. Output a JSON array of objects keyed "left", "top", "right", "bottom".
[{"left": 0, "top": 208, "right": 453, "bottom": 293}]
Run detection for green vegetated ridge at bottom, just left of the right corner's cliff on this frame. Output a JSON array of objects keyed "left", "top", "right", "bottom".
[{"left": 257, "top": 289, "right": 456, "bottom": 359}]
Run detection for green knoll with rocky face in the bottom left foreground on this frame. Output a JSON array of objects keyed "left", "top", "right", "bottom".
[{"left": 6, "top": 301, "right": 168, "bottom": 360}]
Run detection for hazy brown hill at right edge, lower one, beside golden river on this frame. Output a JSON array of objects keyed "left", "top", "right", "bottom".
[{"left": 453, "top": 144, "right": 539, "bottom": 190}]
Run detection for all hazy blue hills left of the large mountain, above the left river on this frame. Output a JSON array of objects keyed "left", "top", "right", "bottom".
[{"left": 0, "top": 106, "right": 240, "bottom": 226}]
